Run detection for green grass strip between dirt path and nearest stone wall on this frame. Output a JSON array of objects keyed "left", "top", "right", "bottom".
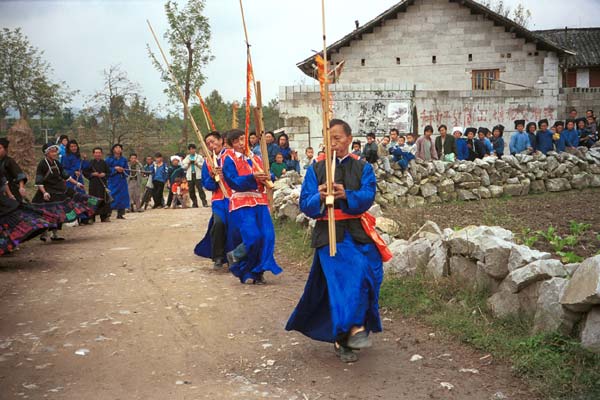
[{"left": 381, "top": 274, "right": 600, "bottom": 399}]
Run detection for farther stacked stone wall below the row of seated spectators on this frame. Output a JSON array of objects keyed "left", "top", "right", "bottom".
[{"left": 376, "top": 147, "right": 600, "bottom": 208}]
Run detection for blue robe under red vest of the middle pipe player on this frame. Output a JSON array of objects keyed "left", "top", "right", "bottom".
[{"left": 223, "top": 157, "right": 283, "bottom": 283}]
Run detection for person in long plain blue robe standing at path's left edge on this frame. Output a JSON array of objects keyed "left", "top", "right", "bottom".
[{"left": 106, "top": 143, "right": 130, "bottom": 219}]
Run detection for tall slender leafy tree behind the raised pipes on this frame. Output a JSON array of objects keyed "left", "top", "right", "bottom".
[{"left": 147, "top": 0, "right": 213, "bottom": 148}]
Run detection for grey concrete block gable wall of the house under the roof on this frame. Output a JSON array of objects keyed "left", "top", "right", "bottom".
[{"left": 332, "top": 0, "right": 560, "bottom": 90}]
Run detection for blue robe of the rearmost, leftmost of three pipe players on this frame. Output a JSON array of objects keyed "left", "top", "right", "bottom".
[{"left": 194, "top": 159, "right": 233, "bottom": 260}]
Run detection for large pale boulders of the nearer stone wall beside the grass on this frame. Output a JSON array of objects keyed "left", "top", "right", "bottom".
[{"left": 385, "top": 222, "right": 600, "bottom": 353}]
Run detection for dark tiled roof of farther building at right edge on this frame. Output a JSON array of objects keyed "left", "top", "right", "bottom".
[{"left": 534, "top": 28, "right": 600, "bottom": 67}]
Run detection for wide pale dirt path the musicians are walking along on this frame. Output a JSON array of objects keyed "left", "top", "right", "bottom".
[{"left": 0, "top": 209, "right": 532, "bottom": 400}]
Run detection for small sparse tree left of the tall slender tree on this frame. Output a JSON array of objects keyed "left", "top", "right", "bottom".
[{"left": 89, "top": 65, "right": 139, "bottom": 146}]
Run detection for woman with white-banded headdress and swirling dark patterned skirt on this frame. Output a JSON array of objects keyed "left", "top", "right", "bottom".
[{"left": 31, "top": 143, "right": 99, "bottom": 241}]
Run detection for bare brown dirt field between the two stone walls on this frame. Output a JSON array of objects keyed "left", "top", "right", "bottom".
[{"left": 385, "top": 189, "right": 600, "bottom": 257}]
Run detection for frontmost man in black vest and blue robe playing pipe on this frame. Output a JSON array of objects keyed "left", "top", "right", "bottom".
[{"left": 286, "top": 119, "right": 391, "bottom": 362}]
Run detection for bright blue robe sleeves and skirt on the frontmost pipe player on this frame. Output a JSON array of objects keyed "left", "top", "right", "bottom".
[{"left": 285, "top": 164, "right": 383, "bottom": 343}]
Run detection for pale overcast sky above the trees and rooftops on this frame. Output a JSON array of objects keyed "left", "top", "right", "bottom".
[{"left": 0, "top": 0, "right": 600, "bottom": 112}]
